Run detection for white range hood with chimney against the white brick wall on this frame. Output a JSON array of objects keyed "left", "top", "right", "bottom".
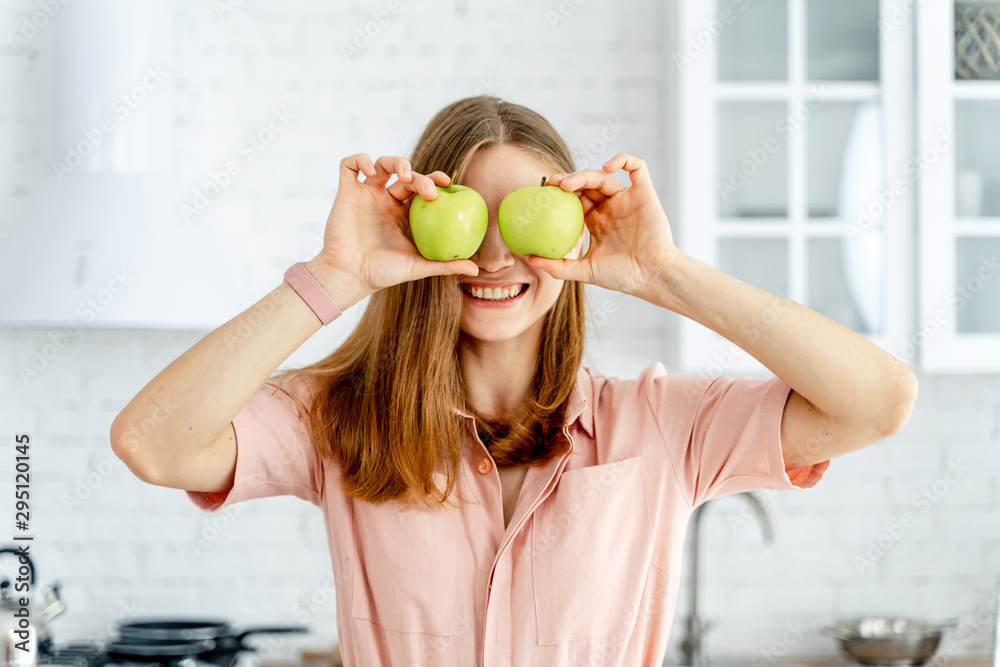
[{"left": 0, "top": 0, "right": 240, "bottom": 329}]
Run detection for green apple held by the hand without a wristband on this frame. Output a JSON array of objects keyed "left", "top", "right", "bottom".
[{"left": 497, "top": 178, "right": 583, "bottom": 259}]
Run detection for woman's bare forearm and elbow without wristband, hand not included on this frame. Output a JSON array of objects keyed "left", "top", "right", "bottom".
[{"left": 636, "top": 251, "right": 917, "bottom": 469}]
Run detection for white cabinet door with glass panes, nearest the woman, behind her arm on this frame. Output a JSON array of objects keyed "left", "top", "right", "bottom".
[{"left": 670, "top": 0, "right": 916, "bottom": 375}]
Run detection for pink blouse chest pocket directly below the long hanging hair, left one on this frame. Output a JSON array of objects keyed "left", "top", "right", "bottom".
[{"left": 351, "top": 501, "right": 459, "bottom": 637}]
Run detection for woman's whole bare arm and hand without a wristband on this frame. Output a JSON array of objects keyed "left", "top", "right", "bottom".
[{"left": 530, "top": 153, "right": 917, "bottom": 470}]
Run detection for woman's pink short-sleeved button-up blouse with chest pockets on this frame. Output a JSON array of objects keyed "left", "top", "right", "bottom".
[{"left": 187, "top": 362, "right": 830, "bottom": 667}]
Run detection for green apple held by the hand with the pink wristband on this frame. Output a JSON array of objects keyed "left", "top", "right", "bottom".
[{"left": 410, "top": 183, "right": 490, "bottom": 262}]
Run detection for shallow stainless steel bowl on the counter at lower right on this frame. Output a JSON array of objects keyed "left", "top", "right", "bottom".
[{"left": 819, "top": 618, "right": 956, "bottom": 667}]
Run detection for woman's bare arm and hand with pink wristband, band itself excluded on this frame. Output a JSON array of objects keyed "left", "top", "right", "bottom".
[{"left": 111, "top": 153, "right": 479, "bottom": 491}]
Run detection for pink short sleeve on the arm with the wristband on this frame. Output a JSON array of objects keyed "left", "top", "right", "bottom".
[{"left": 186, "top": 380, "right": 323, "bottom": 512}]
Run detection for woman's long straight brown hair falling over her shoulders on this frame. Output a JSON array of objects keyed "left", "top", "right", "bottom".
[{"left": 274, "top": 96, "right": 586, "bottom": 508}]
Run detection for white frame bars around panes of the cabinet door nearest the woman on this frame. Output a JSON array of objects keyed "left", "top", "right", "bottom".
[{"left": 666, "top": 0, "right": 916, "bottom": 375}]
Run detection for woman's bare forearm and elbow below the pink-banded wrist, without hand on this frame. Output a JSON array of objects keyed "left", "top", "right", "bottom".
[{"left": 111, "top": 259, "right": 366, "bottom": 491}]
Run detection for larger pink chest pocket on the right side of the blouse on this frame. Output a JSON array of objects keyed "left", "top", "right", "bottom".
[{"left": 531, "top": 456, "right": 652, "bottom": 645}]
